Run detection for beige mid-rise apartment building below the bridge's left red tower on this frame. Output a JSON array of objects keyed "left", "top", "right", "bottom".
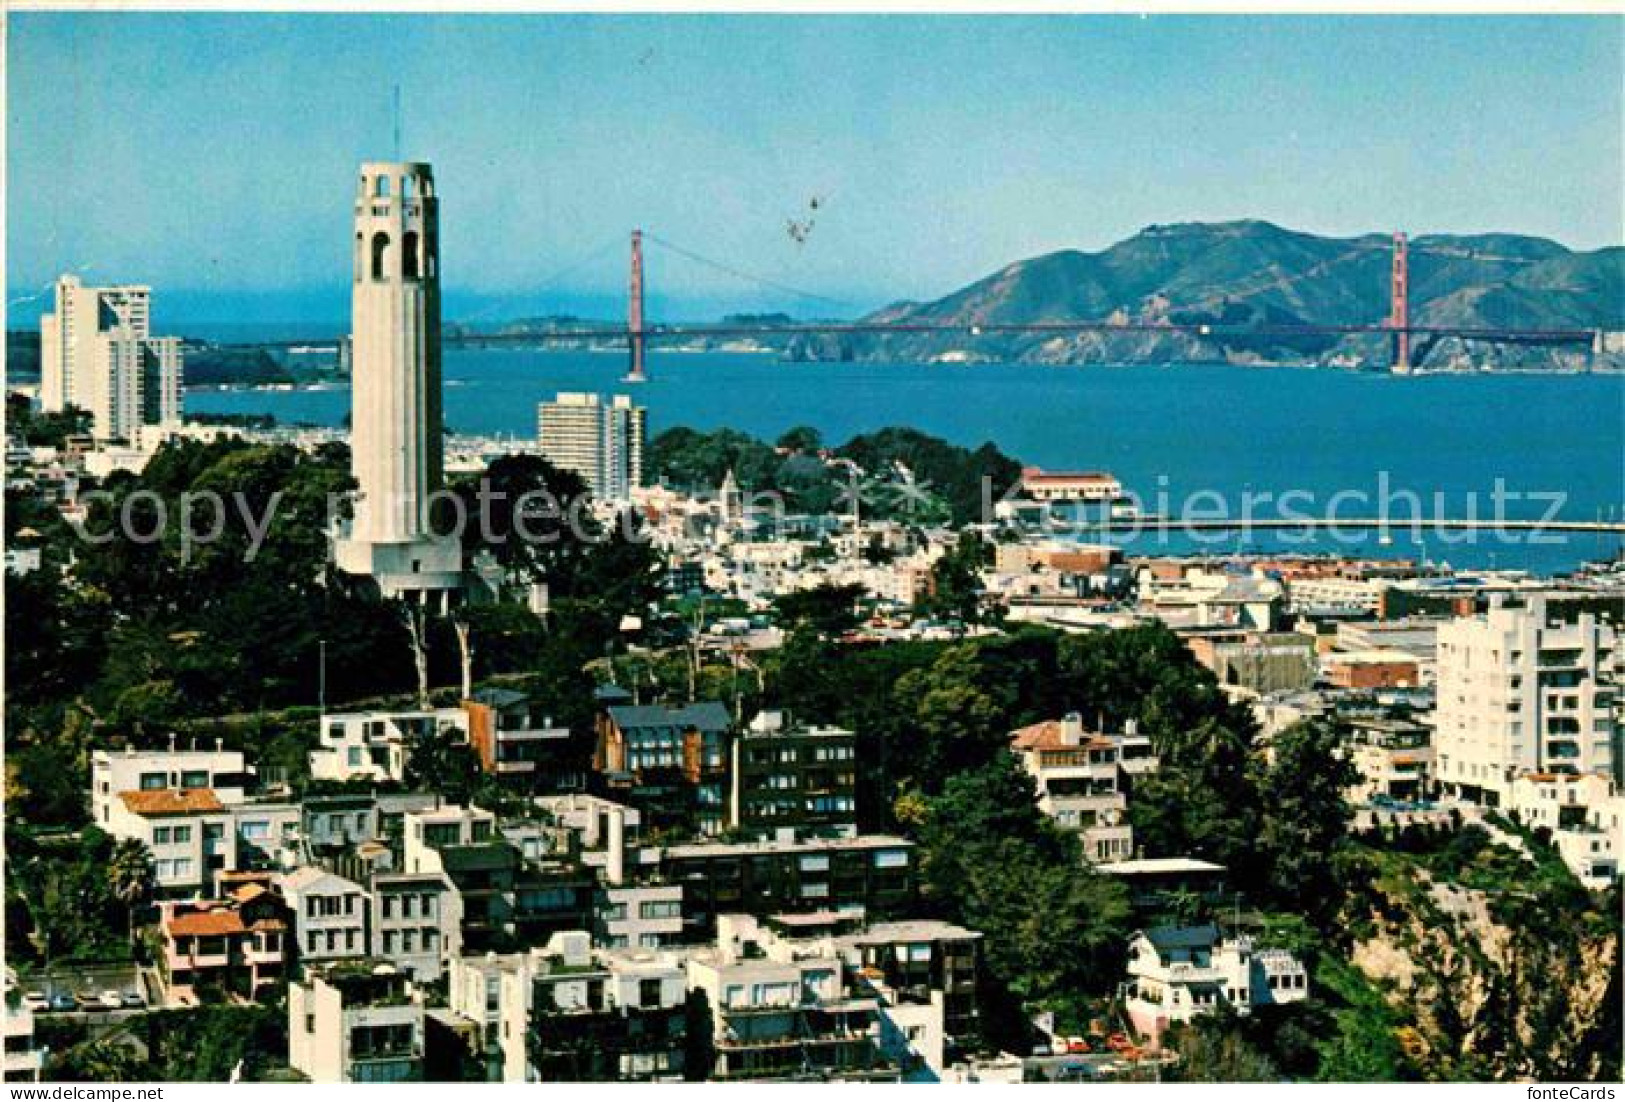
[{"left": 536, "top": 393, "right": 647, "bottom": 501}]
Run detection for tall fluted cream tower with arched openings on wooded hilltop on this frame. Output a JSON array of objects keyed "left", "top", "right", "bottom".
[{"left": 335, "top": 163, "right": 463, "bottom": 600}]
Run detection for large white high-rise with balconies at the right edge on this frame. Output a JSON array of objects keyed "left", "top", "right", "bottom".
[{"left": 1435, "top": 595, "right": 1619, "bottom": 806}]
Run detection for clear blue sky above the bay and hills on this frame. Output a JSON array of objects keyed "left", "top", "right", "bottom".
[{"left": 7, "top": 13, "right": 1625, "bottom": 325}]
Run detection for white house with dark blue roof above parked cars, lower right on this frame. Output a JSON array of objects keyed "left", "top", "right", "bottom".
[{"left": 1126, "top": 925, "right": 1310, "bottom": 1037}]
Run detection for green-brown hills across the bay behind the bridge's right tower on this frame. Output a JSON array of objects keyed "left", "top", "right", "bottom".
[{"left": 790, "top": 221, "right": 1625, "bottom": 367}]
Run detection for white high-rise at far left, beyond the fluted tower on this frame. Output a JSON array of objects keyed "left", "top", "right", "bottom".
[{"left": 39, "top": 275, "right": 182, "bottom": 442}]
